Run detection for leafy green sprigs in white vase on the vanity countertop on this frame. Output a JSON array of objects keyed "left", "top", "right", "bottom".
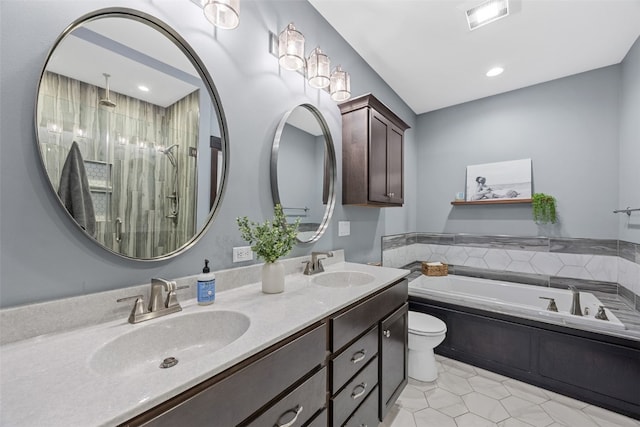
[{"left": 236, "top": 204, "right": 300, "bottom": 294}]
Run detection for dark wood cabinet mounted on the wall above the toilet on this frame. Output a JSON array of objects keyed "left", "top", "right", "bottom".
[{"left": 339, "top": 94, "right": 409, "bottom": 207}]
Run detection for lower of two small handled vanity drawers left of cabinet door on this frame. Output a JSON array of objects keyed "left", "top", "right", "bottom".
[{"left": 331, "top": 356, "right": 378, "bottom": 426}]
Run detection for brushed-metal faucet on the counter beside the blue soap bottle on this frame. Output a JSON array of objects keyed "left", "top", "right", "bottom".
[{"left": 116, "top": 278, "right": 188, "bottom": 323}]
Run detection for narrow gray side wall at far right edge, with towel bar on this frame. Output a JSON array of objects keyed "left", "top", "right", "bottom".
[{"left": 617, "top": 38, "right": 640, "bottom": 243}]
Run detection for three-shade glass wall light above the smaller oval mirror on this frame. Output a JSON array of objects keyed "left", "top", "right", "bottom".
[{"left": 269, "top": 22, "right": 351, "bottom": 102}]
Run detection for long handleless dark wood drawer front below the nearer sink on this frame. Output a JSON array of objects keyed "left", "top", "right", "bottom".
[{"left": 138, "top": 323, "right": 327, "bottom": 427}]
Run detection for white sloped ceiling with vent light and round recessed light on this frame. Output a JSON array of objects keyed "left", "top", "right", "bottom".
[{"left": 302, "top": 0, "right": 640, "bottom": 114}]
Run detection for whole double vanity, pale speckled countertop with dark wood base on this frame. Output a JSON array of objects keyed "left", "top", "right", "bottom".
[{"left": 0, "top": 254, "right": 408, "bottom": 427}]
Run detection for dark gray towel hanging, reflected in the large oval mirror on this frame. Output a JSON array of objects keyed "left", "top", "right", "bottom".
[{"left": 58, "top": 141, "right": 96, "bottom": 236}]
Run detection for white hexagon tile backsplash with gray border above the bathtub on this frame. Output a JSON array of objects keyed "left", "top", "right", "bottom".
[{"left": 382, "top": 233, "right": 640, "bottom": 310}]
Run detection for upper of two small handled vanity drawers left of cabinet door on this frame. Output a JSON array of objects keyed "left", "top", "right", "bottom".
[{"left": 331, "top": 326, "right": 379, "bottom": 395}]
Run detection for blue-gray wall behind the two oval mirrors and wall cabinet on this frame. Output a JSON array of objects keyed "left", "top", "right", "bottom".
[{"left": 0, "top": 0, "right": 417, "bottom": 307}]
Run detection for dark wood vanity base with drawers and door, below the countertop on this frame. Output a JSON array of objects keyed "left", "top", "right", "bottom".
[{"left": 123, "top": 279, "right": 408, "bottom": 427}]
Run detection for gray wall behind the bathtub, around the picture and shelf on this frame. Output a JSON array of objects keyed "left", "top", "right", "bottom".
[{"left": 416, "top": 65, "right": 624, "bottom": 239}]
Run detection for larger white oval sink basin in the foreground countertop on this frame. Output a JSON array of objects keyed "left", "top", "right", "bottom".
[{"left": 89, "top": 311, "right": 251, "bottom": 375}]
